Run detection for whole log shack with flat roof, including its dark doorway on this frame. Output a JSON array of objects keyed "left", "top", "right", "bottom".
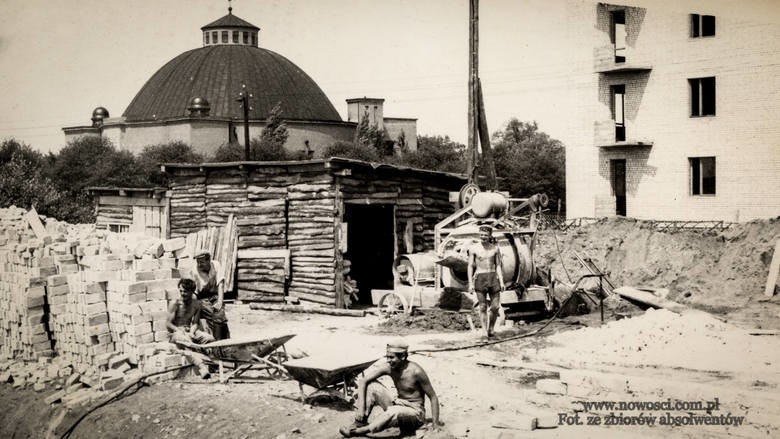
[{"left": 162, "top": 158, "right": 466, "bottom": 307}]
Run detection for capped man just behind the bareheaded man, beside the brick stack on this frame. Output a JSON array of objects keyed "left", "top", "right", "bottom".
[{"left": 187, "top": 251, "right": 230, "bottom": 340}]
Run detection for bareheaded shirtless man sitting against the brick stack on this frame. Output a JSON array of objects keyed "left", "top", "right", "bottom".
[{"left": 165, "top": 279, "right": 214, "bottom": 378}]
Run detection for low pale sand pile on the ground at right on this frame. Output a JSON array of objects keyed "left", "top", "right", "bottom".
[{"left": 541, "top": 309, "right": 780, "bottom": 373}]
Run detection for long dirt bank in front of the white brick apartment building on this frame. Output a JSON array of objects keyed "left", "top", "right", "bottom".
[{"left": 535, "top": 218, "right": 780, "bottom": 312}]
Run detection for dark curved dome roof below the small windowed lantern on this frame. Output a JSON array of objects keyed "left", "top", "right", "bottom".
[{"left": 123, "top": 45, "right": 341, "bottom": 122}]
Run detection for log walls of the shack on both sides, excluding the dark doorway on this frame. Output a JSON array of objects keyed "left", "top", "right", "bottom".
[{"left": 169, "top": 164, "right": 462, "bottom": 307}]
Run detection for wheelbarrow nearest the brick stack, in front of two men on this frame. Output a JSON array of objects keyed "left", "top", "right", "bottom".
[{"left": 180, "top": 334, "right": 295, "bottom": 382}]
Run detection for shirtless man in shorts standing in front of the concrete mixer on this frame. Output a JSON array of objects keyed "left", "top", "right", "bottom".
[{"left": 468, "top": 225, "right": 504, "bottom": 338}]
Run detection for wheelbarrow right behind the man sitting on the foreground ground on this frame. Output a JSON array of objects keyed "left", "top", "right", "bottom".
[{"left": 283, "top": 356, "right": 377, "bottom": 404}]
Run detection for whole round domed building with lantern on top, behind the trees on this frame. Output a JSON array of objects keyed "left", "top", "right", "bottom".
[{"left": 63, "top": 9, "right": 417, "bottom": 156}]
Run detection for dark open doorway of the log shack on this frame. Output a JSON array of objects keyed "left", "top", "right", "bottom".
[{"left": 344, "top": 204, "right": 395, "bottom": 305}]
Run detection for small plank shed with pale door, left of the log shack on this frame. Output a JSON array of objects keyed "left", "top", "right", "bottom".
[{"left": 86, "top": 187, "right": 168, "bottom": 239}]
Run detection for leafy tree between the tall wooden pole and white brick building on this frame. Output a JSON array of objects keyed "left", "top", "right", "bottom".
[{"left": 492, "top": 118, "right": 566, "bottom": 207}]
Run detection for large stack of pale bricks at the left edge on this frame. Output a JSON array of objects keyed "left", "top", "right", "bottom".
[{"left": 0, "top": 207, "right": 207, "bottom": 403}]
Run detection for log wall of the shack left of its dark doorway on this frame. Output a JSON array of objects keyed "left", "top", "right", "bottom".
[{"left": 171, "top": 167, "right": 336, "bottom": 305}]
